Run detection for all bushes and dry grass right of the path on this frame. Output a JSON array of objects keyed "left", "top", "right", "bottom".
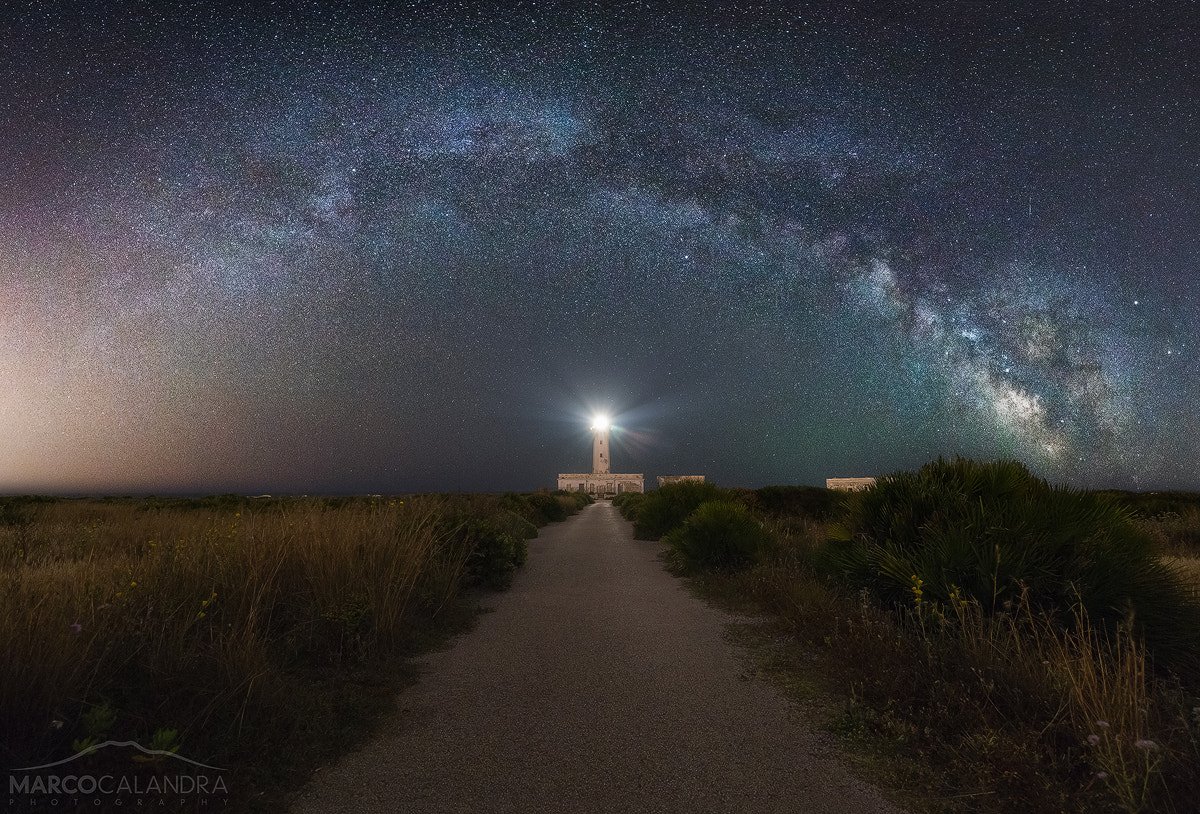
[{"left": 614, "top": 460, "right": 1200, "bottom": 814}]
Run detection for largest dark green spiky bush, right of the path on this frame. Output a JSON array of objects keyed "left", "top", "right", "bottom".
[{"left": 822, "top": 459, "right": 1200, "bottom": 677}]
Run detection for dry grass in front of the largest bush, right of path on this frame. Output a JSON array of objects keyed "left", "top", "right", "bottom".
[{"left": 697, "top": 519, "right": 1200, "bottom": 813}]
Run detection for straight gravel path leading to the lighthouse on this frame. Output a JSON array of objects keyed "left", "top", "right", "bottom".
[{"left": 292, "top": 502, "right": 899, "bottom": 814}]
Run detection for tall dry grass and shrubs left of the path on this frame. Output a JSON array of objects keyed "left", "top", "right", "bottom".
[{"left": 0, "top": 492, "right": 590, "bottom": 810}]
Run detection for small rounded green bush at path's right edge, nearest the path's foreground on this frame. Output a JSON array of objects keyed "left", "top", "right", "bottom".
[{"left": 664, "top": 501, "right": 772, "bottom": 570}]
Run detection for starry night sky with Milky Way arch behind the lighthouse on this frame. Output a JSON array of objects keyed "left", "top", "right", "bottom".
[{"left": 0, "top": 0, "right": 1200, "bottom": 495}]
